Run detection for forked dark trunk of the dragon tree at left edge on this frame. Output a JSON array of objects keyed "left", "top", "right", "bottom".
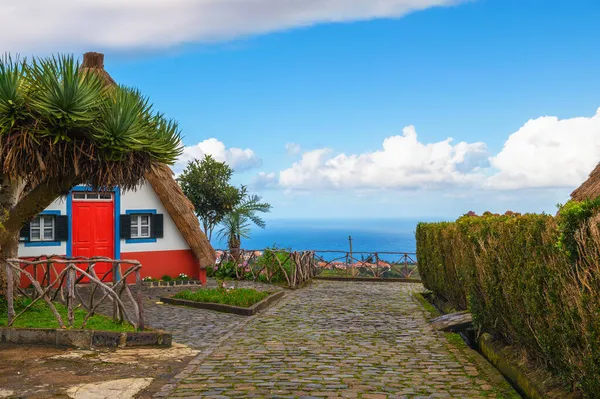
[{"left": 0, "top": 175, "right": 77, "bottom": 296}]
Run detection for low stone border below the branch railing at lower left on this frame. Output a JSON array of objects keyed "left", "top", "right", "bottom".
[{"left": 0, "top": 327, "right": 172, "bottom": 349}]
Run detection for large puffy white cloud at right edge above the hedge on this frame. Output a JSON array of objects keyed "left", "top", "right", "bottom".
[{"left": 487, "top": 109, "right": 600, "bottom": 189}]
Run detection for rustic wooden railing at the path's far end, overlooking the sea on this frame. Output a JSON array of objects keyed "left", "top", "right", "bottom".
[{"left": 215, "top": 249, "right": 418, "bottom": 288}]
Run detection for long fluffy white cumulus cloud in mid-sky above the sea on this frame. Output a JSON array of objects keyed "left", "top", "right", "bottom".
[{"left": 279, "top": 126, "right": 488, "bottom": 189}]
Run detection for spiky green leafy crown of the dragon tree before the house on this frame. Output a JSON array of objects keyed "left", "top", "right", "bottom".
[{"left": 0, "top": 56, "right": 182, "bottom": 189}]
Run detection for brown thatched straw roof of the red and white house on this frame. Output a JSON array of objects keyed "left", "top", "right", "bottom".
[{"left": 82, "top": 53, "right": 217, "bottom": 268}]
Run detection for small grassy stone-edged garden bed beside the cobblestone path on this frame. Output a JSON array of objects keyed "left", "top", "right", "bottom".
[{"left": 160, "top": 288, "right": 285, "bottom": 316}]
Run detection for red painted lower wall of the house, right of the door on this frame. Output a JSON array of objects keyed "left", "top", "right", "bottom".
[{"left": 121, "top": 249, "right": 206, "bottom": 283}]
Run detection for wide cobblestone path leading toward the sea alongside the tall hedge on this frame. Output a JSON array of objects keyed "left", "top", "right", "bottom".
[{"left": 157, "top": 281, "right": 519, "bottom": 399}]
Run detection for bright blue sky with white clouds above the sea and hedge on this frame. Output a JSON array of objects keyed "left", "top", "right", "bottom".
[{"left": 9, "top": 0, "right": 600, "bottom": 218}]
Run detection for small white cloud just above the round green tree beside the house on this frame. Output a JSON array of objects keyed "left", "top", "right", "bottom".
[{"left": 173, "top": 138, "right": 262, "bottom": 173}]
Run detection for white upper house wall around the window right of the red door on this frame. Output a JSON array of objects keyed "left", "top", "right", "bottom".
[{"left": 121, "top": 182, "right": 190, "bottom": 253}]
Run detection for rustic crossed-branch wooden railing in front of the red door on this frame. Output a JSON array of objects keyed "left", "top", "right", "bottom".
[{"left": 6, "top": 256, "right": 144, "bottom": 330}]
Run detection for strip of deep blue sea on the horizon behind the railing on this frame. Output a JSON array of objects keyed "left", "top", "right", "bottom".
[{"left": 212, "top": 218, "right": 438, "bottom": 253}]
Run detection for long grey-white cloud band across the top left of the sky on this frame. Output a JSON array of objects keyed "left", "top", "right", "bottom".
[{"left": 0, "top": 0, "right": 472, "bottom": 53}]
